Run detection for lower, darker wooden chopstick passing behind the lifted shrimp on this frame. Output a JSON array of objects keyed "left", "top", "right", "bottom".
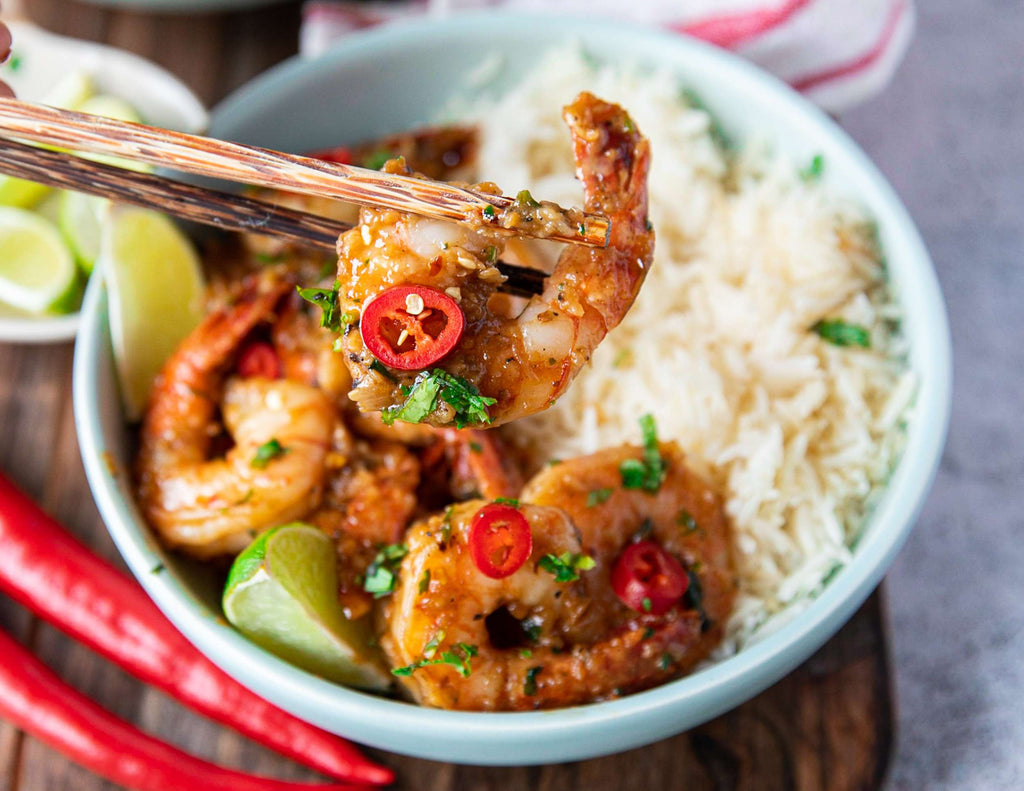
[{"left": 0, "top": 138, "right": 545, "bottom": 296}]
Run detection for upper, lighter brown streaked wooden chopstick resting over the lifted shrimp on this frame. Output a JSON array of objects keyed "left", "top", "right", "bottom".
[{"left": 0, "top": 98, "right": 609, "bottom": 247}]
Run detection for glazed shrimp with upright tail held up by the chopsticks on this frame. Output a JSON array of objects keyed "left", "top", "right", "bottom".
[{"left": 338, "top": 93, "right": 654, "bottom": 426}]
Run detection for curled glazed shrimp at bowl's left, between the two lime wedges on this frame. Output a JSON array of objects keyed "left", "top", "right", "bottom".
[{"left": 136, "top": 278, "right": 335, "bottom": 557}]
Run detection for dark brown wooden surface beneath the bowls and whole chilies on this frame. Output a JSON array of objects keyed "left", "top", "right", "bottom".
[{"left": 0, "top": 0, "right": 893, "bottom": 791}]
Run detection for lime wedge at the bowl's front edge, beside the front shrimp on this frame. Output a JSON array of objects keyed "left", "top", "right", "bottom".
[{"left": 223, "top": 524, "right": 390, "bottom": 690}]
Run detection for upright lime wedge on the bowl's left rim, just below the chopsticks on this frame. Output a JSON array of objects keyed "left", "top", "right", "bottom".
[{"left": 97, "top": 206, "right": 204, "bottom": 420}]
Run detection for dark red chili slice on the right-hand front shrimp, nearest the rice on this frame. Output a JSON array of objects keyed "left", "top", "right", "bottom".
[{"left": 611, "top": 541, "right": 690, "bottom": 615}]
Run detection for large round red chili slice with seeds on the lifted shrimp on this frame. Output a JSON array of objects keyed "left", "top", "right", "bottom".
[{"left": 359, "top": 286, "right": 466, "bottom": 371}]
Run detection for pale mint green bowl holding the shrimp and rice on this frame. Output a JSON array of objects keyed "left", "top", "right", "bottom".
[{"left": 74, "top": 13, "right": 951, "bottom": 764}]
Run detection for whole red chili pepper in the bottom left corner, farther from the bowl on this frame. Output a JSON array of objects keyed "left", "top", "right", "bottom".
[{"left": 0, "top": 630, "right": 366, "bottom": 791}]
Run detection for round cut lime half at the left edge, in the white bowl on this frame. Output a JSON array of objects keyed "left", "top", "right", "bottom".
[{"left": 0, "top": 208, "right": 80, "bottom": 314}]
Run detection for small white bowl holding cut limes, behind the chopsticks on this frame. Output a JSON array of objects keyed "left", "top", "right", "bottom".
[{"left": 0, "top": 22, "right": 208, "bottom": 343}]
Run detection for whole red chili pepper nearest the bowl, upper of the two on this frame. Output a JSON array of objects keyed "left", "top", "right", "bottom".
[{"left": 0, "top": 475, "right": 394, "bottom": 788}]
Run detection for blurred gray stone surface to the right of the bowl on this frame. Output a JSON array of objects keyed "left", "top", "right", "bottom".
[{"left": 843, "top": 0, "right": 1024, "bottom": 791}]
